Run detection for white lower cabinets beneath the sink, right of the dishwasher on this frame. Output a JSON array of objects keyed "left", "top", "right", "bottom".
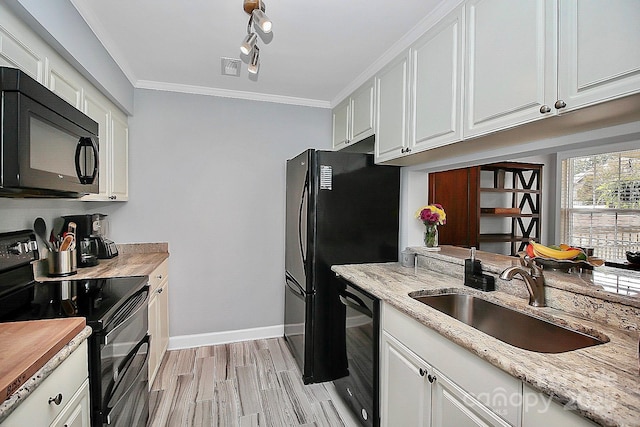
[{"left": 380, "top": 304, "right": 594, "bottom": 427}]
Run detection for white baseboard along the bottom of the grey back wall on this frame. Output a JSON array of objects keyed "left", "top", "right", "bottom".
[{"left": 168, "top": 325, "right": 284, "bottom": 350}]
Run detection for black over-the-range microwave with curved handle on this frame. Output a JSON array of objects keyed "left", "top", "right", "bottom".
[{"left": 0, "top": 67, "right": 99, "bottom": 197}]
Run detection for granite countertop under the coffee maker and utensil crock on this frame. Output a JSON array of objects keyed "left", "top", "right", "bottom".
[{"left": 34, "top": 243, "right": 169, "bottom": 282}]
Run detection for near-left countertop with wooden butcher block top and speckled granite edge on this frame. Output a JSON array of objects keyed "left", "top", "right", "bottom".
[{"left": 0, "top": 317, "right": 91, "bottom": 422}]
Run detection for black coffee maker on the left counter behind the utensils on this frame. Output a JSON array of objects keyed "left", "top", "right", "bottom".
[{"left": 62, "top": 213, "right": 118, "bottom": 267}]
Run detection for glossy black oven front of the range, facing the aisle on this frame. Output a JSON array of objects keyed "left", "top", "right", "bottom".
[{"left": 97, "top": 286, "right": 150, "bottom": 427}]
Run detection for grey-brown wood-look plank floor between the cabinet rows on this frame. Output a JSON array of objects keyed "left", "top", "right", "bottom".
[{"left": 149, "top": 338, "right": 345, "bottom": 427}]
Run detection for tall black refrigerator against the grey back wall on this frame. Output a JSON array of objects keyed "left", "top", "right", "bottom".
[{"left": 284, "top": 150, "right": 400, "bottom": 384}]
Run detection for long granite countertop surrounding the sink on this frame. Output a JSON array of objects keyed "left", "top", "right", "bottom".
[{"left": 332, "top": 248, "right": 640, "bottom": 426}]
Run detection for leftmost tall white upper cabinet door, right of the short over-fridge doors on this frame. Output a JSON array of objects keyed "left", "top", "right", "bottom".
[{"left": 375, "top": 52, "right": 409, "bottom": 162}]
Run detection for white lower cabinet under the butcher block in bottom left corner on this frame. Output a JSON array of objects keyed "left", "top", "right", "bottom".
[{"left": 1, "top": 341, "right": 91, "bottom": 427}]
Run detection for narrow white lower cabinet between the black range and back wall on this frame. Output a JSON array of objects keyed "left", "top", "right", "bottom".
[{"left": 149, "top": 260, "right": 169, "bottom": 387}]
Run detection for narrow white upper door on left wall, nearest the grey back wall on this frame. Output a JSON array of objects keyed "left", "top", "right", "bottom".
[{"left": 109, "top": 111, "right": 129, "bottom": 201}]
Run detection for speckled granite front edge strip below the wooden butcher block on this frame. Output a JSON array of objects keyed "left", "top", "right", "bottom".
[{"left": 0, "top": 326, "right": 91, "bottom": 423}]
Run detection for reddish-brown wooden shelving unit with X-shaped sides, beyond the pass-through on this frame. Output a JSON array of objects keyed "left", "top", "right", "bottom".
[{"left": 429, "top": 162, "right": 543, "bottom": 255}]
